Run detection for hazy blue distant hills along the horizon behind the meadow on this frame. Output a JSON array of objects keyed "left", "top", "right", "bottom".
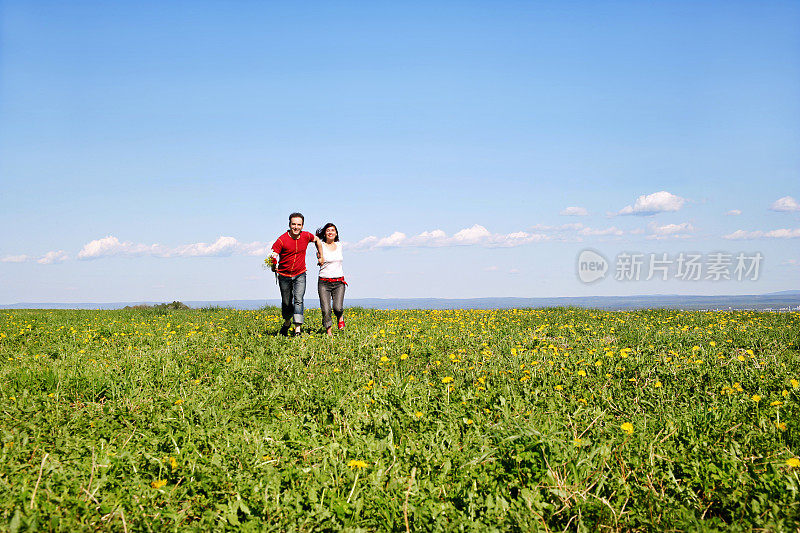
[{"left": 0, "top": 290, "right": 800, "bottom": 311}]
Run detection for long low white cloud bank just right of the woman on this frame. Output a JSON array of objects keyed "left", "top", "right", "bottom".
[{"left": 352, "top": 224, "right": 550, "bottom": 250}]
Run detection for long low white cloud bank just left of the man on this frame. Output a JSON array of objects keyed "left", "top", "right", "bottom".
[{"left": 78, "top": 235, "right": 269, "bottom": 260}]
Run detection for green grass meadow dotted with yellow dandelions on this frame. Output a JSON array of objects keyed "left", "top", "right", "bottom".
[{"left": 0, "top": 309, "right": 800, "bottom": 531}]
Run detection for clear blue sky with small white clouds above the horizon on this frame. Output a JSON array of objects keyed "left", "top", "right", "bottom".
[{"left": 0, "top": 0, "right": 800, "bottom": 303}]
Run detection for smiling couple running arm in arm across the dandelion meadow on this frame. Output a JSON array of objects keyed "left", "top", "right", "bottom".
[{"left": 271, "top": 213, "right": 347, "bottom": 335}]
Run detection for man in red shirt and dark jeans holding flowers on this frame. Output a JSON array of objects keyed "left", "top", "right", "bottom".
[{"left": 272, "top": 213, "right": 322, "bottom": 335}]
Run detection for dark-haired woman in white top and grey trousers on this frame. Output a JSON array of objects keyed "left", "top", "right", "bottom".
[{"left": 317, "top": 222, "right": 347, "bottom": 335}]
